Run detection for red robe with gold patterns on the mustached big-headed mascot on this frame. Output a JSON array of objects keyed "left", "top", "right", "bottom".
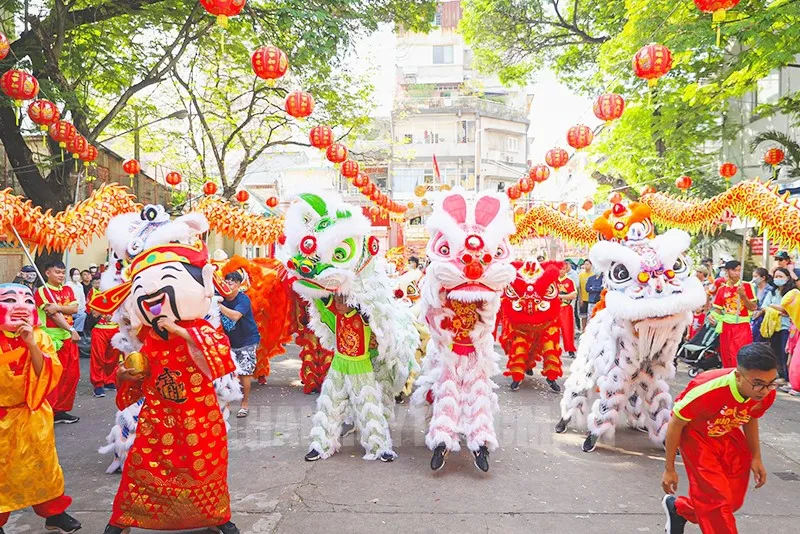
[{"left": 110, "top": 319, "right": 234, "bottom": 530}]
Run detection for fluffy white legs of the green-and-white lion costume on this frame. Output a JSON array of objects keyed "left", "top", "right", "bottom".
[{"left": 309, "top": 369, "right": 394, "bottom": 460}]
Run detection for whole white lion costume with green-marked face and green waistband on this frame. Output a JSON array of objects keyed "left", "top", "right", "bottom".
[{"left": 281, "top": 194, "right": 419, "bottom": 462}]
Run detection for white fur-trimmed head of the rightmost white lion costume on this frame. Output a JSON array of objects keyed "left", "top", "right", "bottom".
[{"left": 589, "top": 229, "right": 705, "bottom": 321}]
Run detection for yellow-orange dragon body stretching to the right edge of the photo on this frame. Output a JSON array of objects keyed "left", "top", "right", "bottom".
[{"left": 640, "top": 180, "right": 800, "bottom": 249}]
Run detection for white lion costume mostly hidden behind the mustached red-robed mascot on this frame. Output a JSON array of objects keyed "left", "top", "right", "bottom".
[{"left": 89, "top": 205, "right": 242, "bottom": 473}]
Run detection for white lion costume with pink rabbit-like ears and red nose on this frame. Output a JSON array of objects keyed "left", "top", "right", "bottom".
[{"left": 412, "top": 192, "right": 516, "bottom": 471}]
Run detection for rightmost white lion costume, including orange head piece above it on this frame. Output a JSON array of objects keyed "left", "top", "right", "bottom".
[{"left": 556, "top": 202, "right": 705, "bottom": 452}]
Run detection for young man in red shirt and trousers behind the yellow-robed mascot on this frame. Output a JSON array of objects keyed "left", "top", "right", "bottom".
[{"left": 35, "top": 261, "right": 81, "bottom": 424}]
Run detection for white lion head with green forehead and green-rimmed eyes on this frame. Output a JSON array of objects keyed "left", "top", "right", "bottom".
[{"left": 281, "top": 193, "right": 379, "bottom": 299}]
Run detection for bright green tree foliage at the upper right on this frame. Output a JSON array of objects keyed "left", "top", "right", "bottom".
[{"left": 461, "top": 0, "right": 800, "bottom": 195}]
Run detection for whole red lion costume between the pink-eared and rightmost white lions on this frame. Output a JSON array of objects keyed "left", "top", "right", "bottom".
[{"left": 500, "top": 261, "right": 564, "bottom": 392}]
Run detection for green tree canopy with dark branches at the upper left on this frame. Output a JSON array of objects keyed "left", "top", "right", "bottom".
[{"left": 0, "top": 0, "right": 435, "bottom": 218}]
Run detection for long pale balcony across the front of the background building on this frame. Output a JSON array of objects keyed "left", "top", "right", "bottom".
[{"left": 393, "top": 96, "right": 529, "bottom": 124}]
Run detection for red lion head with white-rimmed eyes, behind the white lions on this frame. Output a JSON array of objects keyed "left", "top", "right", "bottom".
[{"left": 502, "top": 261, "right": 564, "bottom": 324}]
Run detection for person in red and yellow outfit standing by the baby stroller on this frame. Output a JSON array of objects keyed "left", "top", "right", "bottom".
[{"left": 711, "top": 260, "right": 758, "bottom": 367}]
